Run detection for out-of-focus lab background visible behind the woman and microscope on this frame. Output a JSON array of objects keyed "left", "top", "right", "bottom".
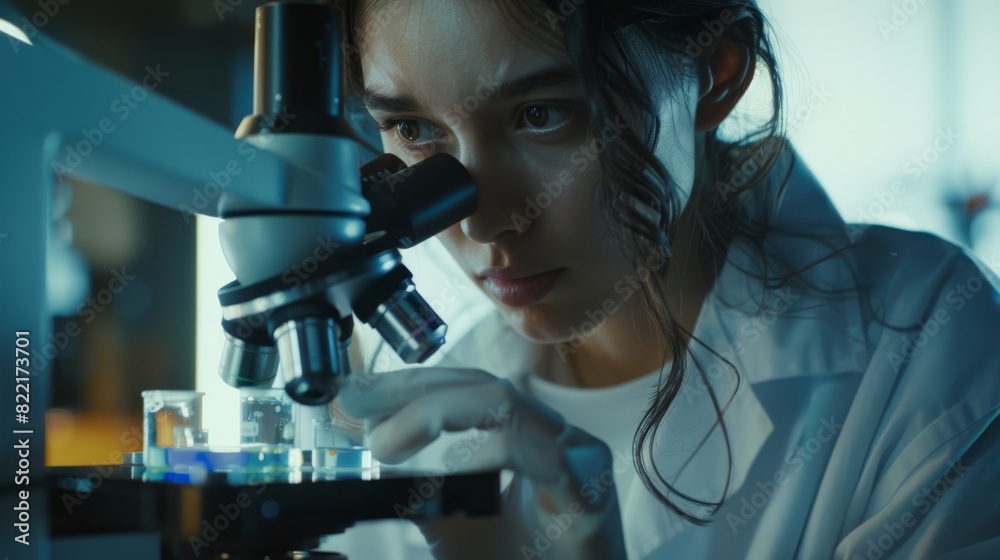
[{"left": 0, "top": 0, "right": 1000, "bottom": 465}]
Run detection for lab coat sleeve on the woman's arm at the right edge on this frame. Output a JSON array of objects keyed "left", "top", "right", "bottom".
[{"left": 834, "top": 240, "right": 1000, "bottom": 560}]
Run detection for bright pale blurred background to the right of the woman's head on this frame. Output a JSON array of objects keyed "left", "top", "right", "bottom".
[{"left": 761, "top": 0, "right": 1000, "bottom": 258}]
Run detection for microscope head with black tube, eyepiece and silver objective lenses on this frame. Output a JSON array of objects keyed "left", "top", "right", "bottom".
[{"left": 219, "top": 3, "right": 476, "bottom": 405}]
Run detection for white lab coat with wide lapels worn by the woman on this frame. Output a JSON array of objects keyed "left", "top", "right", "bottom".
[{"left": 324, "top": 145, "right": 1000, "bottom": 560}]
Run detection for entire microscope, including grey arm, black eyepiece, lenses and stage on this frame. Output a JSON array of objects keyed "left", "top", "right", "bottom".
[{"left": 0, "top": 2, "right": 500, "bottom": 560}]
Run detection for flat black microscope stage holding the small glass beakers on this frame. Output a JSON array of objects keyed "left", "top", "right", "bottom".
[{"left": 47, "top": 465, "right": 500, "bottom": 558}]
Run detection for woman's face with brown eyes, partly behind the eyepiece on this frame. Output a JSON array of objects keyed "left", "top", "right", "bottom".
[{"left": 360, "top": 0, "right": 696, "bottom": 342}]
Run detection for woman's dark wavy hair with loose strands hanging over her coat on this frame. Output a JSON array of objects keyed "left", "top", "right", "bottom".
[{"left": 341, "top": 0, "right": 792, "bottom": 525}]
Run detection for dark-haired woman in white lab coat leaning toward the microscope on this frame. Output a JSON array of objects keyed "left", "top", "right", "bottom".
[{"left": 339, "top": 0, "right": 1000, "bottom": 559}]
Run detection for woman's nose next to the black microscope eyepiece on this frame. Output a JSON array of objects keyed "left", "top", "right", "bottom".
[{"left": 460, "top": 150, "right": 530, "bottom": 244}]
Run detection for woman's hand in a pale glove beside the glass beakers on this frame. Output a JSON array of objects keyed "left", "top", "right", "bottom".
[{"left": 338, "top": 367, "right": 625, "bottom": 560}]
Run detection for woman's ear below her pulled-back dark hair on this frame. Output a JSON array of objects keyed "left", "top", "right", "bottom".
[{"left": 695, "top": 35, "right": 756, "bottom": 132}]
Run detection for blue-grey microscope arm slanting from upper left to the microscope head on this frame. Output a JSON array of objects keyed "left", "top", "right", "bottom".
[{"left": 0, "top": 14, "right": 348, "bottom": 219}]
